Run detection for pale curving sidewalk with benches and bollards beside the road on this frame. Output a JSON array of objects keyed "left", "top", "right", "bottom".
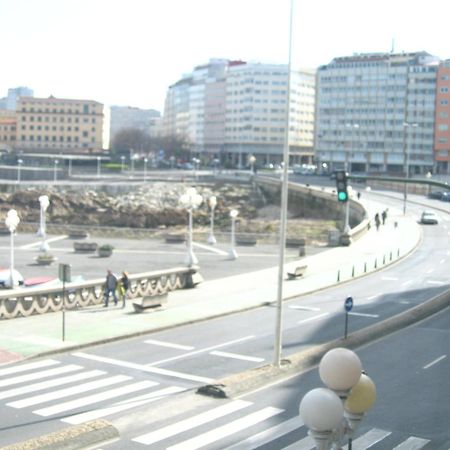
[{"left": 0, "top": 202, "right": 421, "bottom": 364}]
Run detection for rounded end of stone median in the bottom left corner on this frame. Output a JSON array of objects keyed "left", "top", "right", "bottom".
[{"left": 0, "top": 420, "right": 119, "bottom": 450}]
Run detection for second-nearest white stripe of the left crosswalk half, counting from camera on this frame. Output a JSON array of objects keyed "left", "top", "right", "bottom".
[{"left": 33, "top": 381, "right": 154, "bottom": 417}]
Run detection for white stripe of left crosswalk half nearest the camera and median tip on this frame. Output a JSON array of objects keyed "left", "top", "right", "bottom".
[{"left": 62, "top": 386, "right": 186, "bottom": 425}]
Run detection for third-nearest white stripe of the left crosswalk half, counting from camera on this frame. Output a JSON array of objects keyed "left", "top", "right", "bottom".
[{"left": 7, "top": 375, "right": 134, "bottom": 409}]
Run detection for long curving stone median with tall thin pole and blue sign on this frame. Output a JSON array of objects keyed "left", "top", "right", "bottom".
[{"left": 196, "top": 289, "right": 450, "bottom": 398}]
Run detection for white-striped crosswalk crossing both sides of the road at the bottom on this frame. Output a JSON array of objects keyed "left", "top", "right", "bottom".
[{"left": 0, "top": 359, "right": 432, "bottom": 450}]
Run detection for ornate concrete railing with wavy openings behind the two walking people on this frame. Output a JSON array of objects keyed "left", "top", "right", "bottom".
[{"left": 0, "top": 267, "right": 197, "bottom": 319}]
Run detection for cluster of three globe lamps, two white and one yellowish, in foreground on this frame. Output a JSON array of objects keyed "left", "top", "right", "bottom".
[{"left": 299, "top": 348, "right": 376, "bottom": 450}]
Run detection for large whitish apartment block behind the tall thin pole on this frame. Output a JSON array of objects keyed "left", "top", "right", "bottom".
[{"left": 163, "top": 60, "right": 315, "bottom": 166}]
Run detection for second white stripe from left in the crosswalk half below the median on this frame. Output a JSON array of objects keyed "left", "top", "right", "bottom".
[{"left": 167, "top": 406, "right": 283, "bottom": 450}]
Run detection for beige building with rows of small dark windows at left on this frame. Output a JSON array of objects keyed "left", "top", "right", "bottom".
[{"left": 14, "top": 97, "right": 103, "bottom": 153}]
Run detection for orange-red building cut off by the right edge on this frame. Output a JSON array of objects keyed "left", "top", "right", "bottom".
[{"left": 434, "top": 60, "right": 450, "bottom": 173}]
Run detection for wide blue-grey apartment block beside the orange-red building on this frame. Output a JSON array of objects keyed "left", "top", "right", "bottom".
[{"left": 315, "top": 52, "right": 439, "bottom": 174}]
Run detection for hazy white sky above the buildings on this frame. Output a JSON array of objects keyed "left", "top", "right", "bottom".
[{"left": 0, "top": 0, "right": 450, "bottom": 112}]
